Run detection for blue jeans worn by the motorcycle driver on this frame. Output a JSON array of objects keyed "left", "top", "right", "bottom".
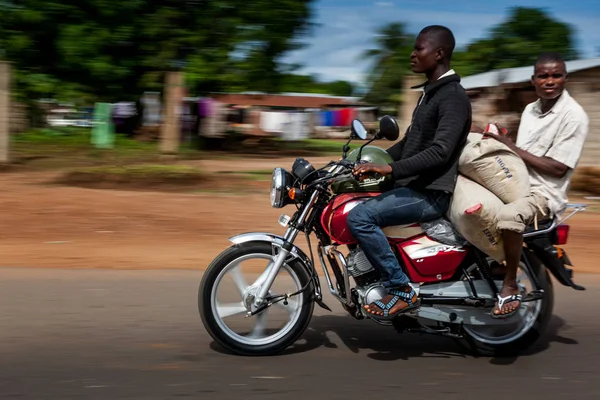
[{"left": 347, "top": 187, "right": 451, "bottom": 288}]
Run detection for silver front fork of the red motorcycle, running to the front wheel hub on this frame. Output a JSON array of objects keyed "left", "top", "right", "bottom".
[{"left": 249, "top": 190, "right": 319, "bottom": 307}]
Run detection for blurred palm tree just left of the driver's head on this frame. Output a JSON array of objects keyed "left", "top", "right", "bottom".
[{"left": 364, "top": 22, "right": 415, "bottom": 108}]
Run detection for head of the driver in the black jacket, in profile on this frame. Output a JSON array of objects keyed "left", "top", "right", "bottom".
[{"left": 410, "top": 25, "right": 456, "bottom": 74}]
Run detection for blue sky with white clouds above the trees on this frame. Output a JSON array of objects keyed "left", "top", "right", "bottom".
[{"left": 286, "top": 0, "right": 600, "bottom": 83}]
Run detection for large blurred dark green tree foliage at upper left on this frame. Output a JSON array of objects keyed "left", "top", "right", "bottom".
[{"left": 0, "top": 0, "right": 312, "bottom": 101}]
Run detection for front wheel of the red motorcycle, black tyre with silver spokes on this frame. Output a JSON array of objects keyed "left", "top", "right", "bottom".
[{"left": 198, "top": 242, "right": 314, "bottom": 356}]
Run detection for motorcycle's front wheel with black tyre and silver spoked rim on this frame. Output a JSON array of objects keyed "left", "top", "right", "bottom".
[{"left": 198, "top": 242, "right": 314, "bottom": 355}]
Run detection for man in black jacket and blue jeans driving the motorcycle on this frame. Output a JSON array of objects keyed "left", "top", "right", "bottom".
[{"left": 348, "top": 25, "right": 472, "bottom": 319}]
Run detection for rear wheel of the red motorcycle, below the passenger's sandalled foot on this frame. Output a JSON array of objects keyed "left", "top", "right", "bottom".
[{"left": 463, "top": 255, "right": 554, "bottom": 356}]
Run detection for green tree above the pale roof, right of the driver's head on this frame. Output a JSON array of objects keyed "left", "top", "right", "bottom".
[{"left": 453, "top": 7, "right": 578, "bottom": 76}]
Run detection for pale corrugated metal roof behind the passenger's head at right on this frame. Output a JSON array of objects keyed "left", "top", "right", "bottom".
[{"left": 461, "top": 58, "right": 600, "bottom": 90}]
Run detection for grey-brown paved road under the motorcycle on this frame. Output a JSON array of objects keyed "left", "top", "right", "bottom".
[{"left": 0, "top": 268, "right": 600, "bottom": 400}]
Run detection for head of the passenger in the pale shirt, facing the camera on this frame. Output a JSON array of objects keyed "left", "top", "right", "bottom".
[{"left": 531, "top": 52, "right": 567, "bottom": 100}]
